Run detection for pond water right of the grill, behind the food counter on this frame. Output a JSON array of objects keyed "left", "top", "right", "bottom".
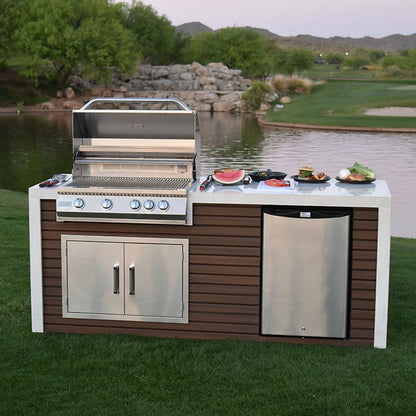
[{"left": 200, "top": 114, "right": 416, "bottom": 238}]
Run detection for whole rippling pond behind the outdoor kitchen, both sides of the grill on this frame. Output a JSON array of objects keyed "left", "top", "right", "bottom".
[{"left": 0, "top": 113, "right": 416, "bottom": 238}]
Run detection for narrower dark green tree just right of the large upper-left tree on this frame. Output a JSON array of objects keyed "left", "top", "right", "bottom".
[{"left": 125, "top": 0, "right": 183, "bottom": 65}]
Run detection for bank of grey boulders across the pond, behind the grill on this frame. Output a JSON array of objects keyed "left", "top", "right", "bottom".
[{"left": 90, "top": 62, "right": 251, "bottom": 112}]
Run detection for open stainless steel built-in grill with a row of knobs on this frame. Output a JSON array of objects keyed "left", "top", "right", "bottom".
[{"left": 57, "top": 98, "right": 199, "bottom": 224}]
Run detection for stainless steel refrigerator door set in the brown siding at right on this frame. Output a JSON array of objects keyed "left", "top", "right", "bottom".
[{"left": 262, "top": 211, "right": 350, "bottom": 338}]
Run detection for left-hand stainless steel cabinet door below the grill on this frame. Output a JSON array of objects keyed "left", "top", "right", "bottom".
[{"left": 64, "top": 241, "right": 124, "bottom": 314}]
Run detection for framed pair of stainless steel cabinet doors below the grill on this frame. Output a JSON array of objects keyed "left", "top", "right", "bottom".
[{"left": 61, "top": 235, "right": 188, "bottom": 323}]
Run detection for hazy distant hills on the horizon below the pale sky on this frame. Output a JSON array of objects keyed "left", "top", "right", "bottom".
[{"left": 176, "top": 22, "right": 416, "bottom": 52}]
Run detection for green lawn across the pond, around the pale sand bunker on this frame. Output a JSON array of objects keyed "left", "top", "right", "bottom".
[{"left": 264, "top": 80, "right": 416, "bottom": 128}]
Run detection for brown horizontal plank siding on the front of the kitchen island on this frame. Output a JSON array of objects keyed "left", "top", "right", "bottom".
[{"left": 41, "top": 200, "right": 377, "bottom": 345}]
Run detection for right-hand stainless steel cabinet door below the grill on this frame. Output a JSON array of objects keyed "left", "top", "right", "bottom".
[{"left": 125, "top": 244, "right": 184, "bottom": 318}]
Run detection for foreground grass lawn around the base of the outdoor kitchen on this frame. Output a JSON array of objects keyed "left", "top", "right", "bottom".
[{"left": 0, "top": 190, "right": 416, "bottom": 416}]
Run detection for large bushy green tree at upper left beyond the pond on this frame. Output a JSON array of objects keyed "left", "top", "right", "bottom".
[{"left": 14, "top": 0, "right": 137, "bottom": 86}]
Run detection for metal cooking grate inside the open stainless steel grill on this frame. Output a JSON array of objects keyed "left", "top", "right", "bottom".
[{"left": 70, "top": 176, "right": 191, "bottom": 190}]
